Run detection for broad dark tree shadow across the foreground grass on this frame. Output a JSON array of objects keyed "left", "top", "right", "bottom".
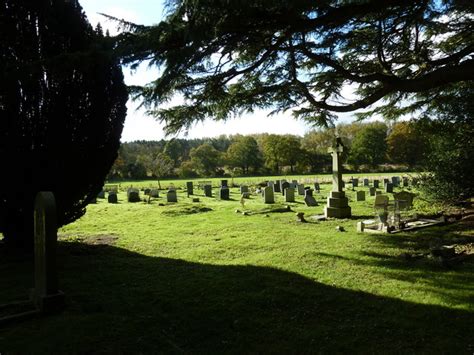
[{"left": 0, "top": 242, "right": 474, "bottom": 353}]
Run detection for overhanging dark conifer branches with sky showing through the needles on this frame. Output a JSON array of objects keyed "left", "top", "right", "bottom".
[{"left": 118, "top": 0, "right": 474, "bottom": 133}]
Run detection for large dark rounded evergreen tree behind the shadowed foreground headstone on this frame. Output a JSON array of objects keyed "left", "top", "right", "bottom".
[{"left": 0, "top": 0, "right": 128, "bottom": 247}]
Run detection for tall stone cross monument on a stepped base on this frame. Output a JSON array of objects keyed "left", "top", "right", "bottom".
[{"left": 322, "top": 137, "right": 351, "bottom": 218}]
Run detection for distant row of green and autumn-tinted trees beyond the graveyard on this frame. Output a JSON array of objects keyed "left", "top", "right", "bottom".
[{"left": 109, "top": 121, "right": 426, "bottom": 179}]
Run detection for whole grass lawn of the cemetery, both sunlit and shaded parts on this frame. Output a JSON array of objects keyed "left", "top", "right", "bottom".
[{"left": 0, "top": 178, "right": 474, "bottom": 354}]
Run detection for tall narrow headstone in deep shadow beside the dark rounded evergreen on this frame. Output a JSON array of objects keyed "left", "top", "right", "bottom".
[{"left": 31, "top": 191, "right": 64, "bottom": 313}]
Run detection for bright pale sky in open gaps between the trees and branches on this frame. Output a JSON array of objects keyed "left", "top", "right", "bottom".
[{"left": 79, "top": 0, "right": 358, "bottom": 142}]
